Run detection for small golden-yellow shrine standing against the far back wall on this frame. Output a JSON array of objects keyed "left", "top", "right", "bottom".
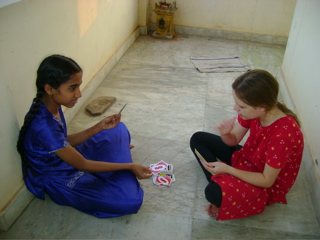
[{"left": 152, "top": 1, "right": 177, "bottom": 39}]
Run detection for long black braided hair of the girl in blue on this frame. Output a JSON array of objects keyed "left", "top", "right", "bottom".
[{"left": 17, "top": 55, "right": 82, "bottom": 178}]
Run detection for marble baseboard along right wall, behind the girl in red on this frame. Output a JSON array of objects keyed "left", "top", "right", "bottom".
[{"left": 276, "top": 68, "right": 320, "bottom": 225}]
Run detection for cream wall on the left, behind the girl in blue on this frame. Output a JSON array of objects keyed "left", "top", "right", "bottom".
[{"left": 0, "top": 0, "right": 139, "bottom": 230}]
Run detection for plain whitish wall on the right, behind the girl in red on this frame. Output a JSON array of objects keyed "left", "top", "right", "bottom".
[{"left": 282, "top": 0, "right": 320, "bottom": 222}]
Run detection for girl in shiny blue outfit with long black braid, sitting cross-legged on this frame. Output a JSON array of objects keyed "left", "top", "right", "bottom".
[{"left": 17, "top": 55, "right": 152, "bottom": 218}]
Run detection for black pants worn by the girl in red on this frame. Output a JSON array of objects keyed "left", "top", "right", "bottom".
[{"left": 190, "top": 132, "right": 242, "bottom": 207}]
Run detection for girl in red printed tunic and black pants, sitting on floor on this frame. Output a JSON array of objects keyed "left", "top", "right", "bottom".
[{"left": 190, "top": 70, "right": 304, "bottom": 220}]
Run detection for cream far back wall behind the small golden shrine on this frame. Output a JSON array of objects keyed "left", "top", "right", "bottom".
[{"left": 150, "top": 0, "right": 296, "bottom": 37}]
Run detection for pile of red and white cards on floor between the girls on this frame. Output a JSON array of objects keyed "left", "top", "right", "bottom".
[{"left": 150, "top": 160, "right": 175, "bottom": 187}]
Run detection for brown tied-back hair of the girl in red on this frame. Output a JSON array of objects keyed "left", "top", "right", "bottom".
[{"left": 232, "top": 69, "right": 300, "bottom": 126}]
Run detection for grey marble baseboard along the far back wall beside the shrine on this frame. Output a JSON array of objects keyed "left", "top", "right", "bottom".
[{"left": 149, "top": 23, "right": 288, "bottom": 45}]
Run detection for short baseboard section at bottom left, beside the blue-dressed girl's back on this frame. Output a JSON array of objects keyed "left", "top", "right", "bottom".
[{"left": 0, "top": 186, "right": 34, "bottom": 231}]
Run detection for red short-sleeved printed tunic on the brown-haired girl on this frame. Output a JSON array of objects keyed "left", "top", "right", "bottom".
[{"left": 211, "top": 116, "right": 304, "bottom": 220}]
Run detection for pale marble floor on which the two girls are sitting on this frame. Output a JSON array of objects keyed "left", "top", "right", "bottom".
[{"left": 0, "top": 36, "right": 320, "bottom": 240}]
